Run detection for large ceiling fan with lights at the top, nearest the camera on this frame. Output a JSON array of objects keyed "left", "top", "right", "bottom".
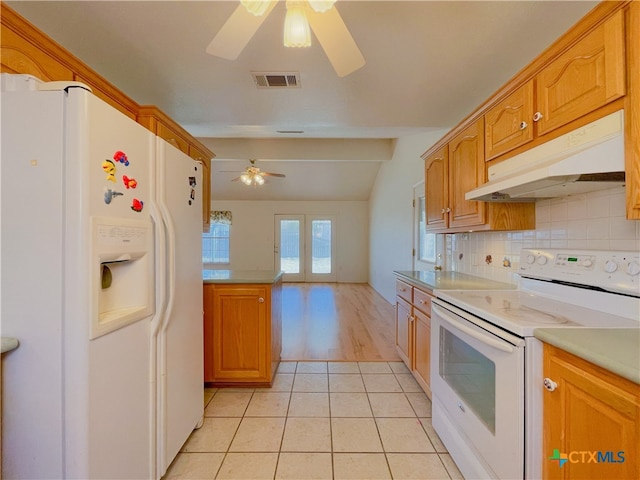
[{"left": 206, "top": 0, "right": 365, "bottom": 77}]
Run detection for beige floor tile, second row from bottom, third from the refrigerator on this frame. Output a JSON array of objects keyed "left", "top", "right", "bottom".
[{"left": 280, "top": 418, "right": 331, "bottom": 452}]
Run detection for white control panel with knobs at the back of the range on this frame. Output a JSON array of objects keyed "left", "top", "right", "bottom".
[{"left": 518, "top": 248, "right": 640, "bottom": 296}]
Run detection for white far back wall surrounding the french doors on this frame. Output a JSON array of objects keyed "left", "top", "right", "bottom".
[{"left": 211, "top": 200, "right": 369, "bottom": 283}]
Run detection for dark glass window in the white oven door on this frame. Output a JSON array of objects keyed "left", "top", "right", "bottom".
[{"left": 439, "top": 327, "right": 496, "bottom": 435}]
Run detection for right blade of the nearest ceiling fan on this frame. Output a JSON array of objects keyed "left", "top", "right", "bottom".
[{"left": 306, "top": 5, "right": 366, "bottom": 77}]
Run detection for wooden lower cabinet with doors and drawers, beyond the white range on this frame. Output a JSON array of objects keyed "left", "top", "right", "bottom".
[{"left": 396, "top": 280, "right": 433, "bottom": 398}]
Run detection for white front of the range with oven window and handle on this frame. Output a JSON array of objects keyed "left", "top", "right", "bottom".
[{"left": 431, "top": 299, "right": 525, "bottom": 479}]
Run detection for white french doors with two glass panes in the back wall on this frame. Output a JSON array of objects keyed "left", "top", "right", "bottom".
[{"left": 274, "top": 215, "right": 336, "bottom": 282}]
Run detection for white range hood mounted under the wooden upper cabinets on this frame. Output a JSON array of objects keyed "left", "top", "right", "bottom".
[{"left": 465, "top": 110, "right": 625, "bottom": 202}]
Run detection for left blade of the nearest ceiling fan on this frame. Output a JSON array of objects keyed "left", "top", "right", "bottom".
[{"left": 206, "top": 0, "right": 278, "bottom": 60}]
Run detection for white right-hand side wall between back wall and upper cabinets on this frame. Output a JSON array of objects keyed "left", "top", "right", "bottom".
[{"left": 369, "top": 130, "right": 448, "bottom": 303}]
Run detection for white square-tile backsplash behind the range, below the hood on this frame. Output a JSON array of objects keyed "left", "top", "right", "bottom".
[{"left": 444, "top": 187, "right": 640, "bottom": 283}]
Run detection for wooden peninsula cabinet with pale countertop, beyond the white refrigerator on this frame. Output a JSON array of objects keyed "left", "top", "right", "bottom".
[{"left": 202, "top": 270, "right": 282, "bottom": 387}]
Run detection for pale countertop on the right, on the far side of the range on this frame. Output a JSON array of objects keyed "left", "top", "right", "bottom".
[{"left": 393, "top": 270, "right": 516, "bottom": 291}]
